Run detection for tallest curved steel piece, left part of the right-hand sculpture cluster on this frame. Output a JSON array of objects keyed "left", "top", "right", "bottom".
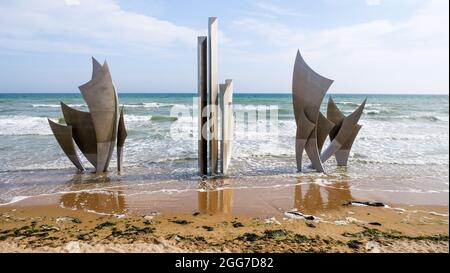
[{"left": 292, "top": 51, "right": 333, "bottom": 172}]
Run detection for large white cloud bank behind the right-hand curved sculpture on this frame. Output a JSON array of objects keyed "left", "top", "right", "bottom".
[{"left": 234, "top": 0, "right": 449, "bottom": 92}]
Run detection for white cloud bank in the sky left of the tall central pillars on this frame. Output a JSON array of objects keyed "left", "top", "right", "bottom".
[{"left": 0, "top": 0, "right": 199, "bottom": 54}]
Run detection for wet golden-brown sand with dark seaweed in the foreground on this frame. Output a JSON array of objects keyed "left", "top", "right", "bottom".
[{"left": 0, "top": 177, "right": 449, "bottom": 252}]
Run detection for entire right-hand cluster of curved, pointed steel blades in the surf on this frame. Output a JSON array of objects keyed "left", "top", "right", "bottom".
[{"left": 292, "top": 51, "right": 367, "bottom": 172}]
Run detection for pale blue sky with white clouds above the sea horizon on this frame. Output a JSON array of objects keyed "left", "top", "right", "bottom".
[{"left": 0, "top": 0, "right": 449, "bottom": 94}]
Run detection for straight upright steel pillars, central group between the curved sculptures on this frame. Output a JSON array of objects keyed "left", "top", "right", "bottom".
[{"left": 198, "top": 17, "right": 234, "bottom": 175}]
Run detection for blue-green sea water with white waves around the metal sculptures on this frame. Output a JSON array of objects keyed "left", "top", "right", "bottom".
[{"left": 0, "top": 93, "right": 449, "bottom": 203}]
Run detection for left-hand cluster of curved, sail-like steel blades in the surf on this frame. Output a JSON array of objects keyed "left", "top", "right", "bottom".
[{"left": 49, "top": 58, "right": 126, "bottom": 173}]
